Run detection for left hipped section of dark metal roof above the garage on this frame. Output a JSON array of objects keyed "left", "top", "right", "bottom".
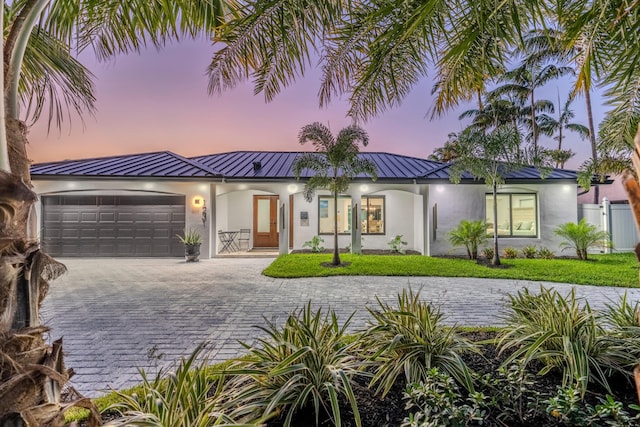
[{"left": 31, "top": 151, "right": 220, "bottom": 178}]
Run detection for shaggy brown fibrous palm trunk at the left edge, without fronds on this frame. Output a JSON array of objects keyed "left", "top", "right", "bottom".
[{"left": 0, "top": 123, "right": 100, "bottom": 427}]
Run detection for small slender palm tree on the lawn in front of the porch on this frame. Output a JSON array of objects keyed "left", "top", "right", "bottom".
[{"left": 292, "top": 122, "right": 378, "bottom": 265}]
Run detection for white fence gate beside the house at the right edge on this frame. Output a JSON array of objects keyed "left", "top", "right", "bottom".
[{"left": 578, "top": 197, "right": 640, "bottom": 253}]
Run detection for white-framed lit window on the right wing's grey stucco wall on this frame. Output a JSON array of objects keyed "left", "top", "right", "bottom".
[{"left": 485, "top": 193, "right": 538, "bottom": 237}]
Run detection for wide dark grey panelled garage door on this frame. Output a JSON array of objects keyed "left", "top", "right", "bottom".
[{"left": 42, "top": 196, "right": 185, "bottom": 257}]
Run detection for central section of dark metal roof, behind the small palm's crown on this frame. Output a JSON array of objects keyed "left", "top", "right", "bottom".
[{"left": 192, "top": 151, "right": 441, "bottom": 180}]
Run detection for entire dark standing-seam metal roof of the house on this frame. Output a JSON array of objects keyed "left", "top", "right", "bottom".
[{"left": 31, "top": 151, "right": 577, "bottom": 182}]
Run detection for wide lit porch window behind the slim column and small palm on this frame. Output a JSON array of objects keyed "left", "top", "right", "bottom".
[{"left": 318, "top": 196, "right": 385, "bottom": 234}]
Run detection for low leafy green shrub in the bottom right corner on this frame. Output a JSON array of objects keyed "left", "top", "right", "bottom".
[{"left": 545, "top": 385, "right": 640, "bottom": 427}]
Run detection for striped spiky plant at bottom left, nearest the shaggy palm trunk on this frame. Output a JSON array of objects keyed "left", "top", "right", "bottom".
[{"left": 107, "top": 345, "right": 249, "bottom": 427}]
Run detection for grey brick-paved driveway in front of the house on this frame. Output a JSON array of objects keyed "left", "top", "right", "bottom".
[{"left": 42, "top": 258, "right": 640, "bottom": 396}]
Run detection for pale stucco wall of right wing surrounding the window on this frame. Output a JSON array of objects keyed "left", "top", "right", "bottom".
[{"left": 429, "top": 182, "right": 578, "bottom": 255}]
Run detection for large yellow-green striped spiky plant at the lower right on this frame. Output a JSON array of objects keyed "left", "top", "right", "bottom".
[{"left": 499, "top": 286, "right": 638, "bottom": 393}]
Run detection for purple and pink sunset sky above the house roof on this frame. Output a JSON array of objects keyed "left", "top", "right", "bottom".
[{"left": 28, "top": 40, "right": 602, "bottom": 168}]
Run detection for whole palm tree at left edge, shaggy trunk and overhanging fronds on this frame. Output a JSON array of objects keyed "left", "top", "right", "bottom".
[{"left": 0, "top": 0, "right": 230, "bottom": 425}]
